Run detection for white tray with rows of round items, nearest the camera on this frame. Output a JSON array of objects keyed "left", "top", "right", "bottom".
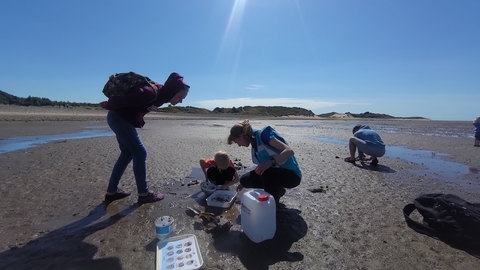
[{"left": 156, "top": 234, "right": 203, "bottom": 270}]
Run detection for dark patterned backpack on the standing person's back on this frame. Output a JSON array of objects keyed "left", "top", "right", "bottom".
[{"left": 102, "top": 71, "right": 158, "bottom": 98}]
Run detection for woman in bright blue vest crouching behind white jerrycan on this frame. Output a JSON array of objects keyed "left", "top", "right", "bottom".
[{"left": 228, "top": 120, "right": 302, "bottom": 206}]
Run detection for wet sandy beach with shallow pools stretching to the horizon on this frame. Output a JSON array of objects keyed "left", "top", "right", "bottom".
[{"left": 0, "top": 106, "right": 480, "bottom": 270}]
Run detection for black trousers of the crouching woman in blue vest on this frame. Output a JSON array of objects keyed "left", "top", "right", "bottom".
[{"left": 240, "top": 168, "right": 302, "bottom": 197}]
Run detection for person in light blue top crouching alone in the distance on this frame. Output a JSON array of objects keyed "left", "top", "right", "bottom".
[{"left": 345, "top": 125, "right": 385, "bottom": 166}]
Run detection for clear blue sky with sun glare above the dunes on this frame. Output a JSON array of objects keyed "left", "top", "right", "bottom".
[{"left": 0, "top": 0, "right": 480, "bottom": 120}]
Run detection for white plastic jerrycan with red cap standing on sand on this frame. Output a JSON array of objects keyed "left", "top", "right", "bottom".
[{"left": 241, "top": 189, "right": 277, "bottom": 243}]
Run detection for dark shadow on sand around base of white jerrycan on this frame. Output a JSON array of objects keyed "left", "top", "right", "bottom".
[{"left": 213, "top": 207, "right": 308, "bottom": 269}]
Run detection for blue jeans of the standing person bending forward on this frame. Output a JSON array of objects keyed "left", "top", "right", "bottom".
[{"left": 107, "top": 111, "right": 148, "bottom": 194}]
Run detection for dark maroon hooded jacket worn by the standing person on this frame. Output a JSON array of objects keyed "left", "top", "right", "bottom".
[{"left": 105, "top": 72, "right": 190, "bottom": 128}]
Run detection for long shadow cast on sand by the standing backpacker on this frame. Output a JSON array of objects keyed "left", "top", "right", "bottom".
[{"left": 0, "top": 203, "right": 138, "bottom": 270}]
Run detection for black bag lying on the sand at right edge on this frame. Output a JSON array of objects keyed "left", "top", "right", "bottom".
[{"left": 403, "top": 194, "right": 480, "bottom": 258}]
